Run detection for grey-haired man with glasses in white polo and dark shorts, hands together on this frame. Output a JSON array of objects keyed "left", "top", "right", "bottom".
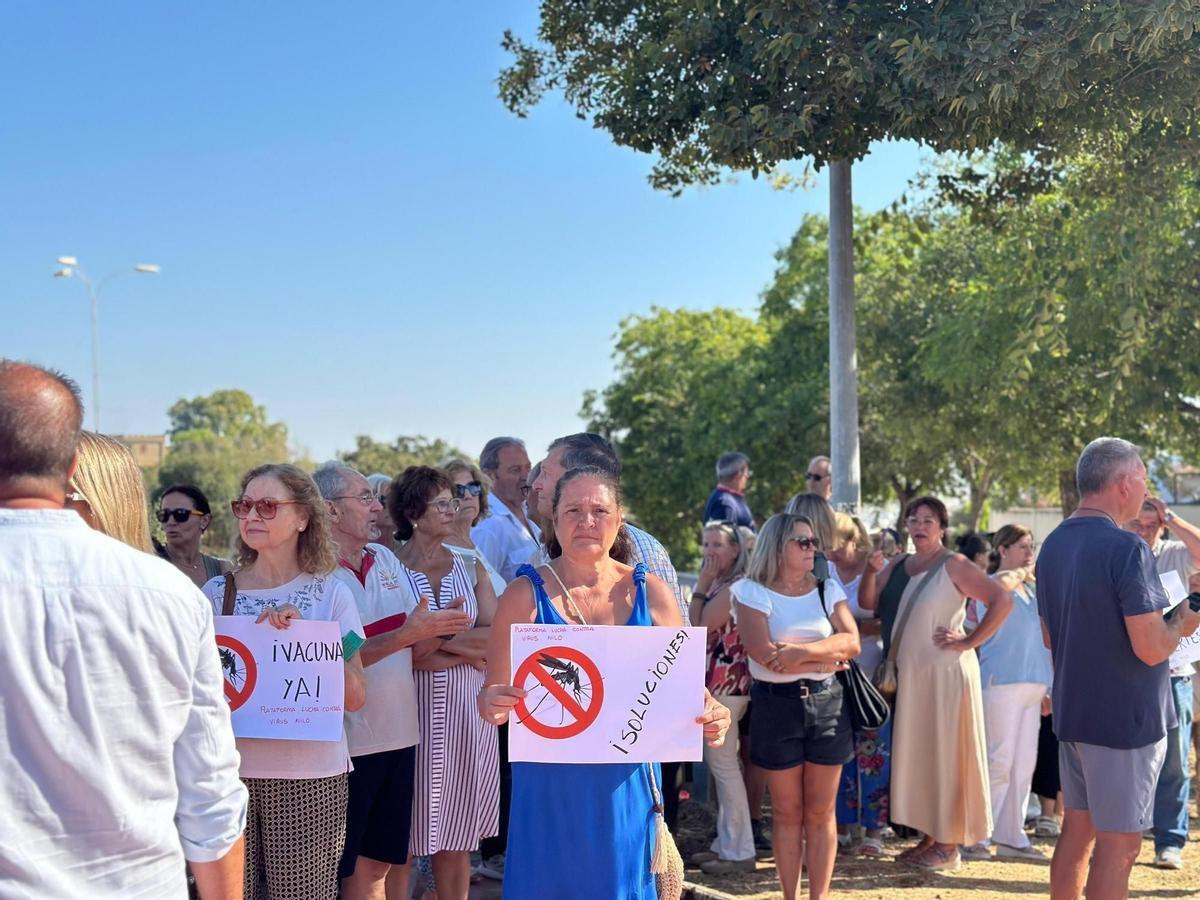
[{"left": 313, "top": 463, "right": 470, "bottom": 900}]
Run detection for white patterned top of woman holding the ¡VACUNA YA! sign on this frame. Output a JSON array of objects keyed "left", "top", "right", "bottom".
[{"left": 202, "top": 572, "right": 366, "bottom": 779}]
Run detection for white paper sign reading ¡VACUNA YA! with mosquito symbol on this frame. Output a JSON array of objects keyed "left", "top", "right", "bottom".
[{"left": 214, "top": 616, "right": 346, "bottom": 740}]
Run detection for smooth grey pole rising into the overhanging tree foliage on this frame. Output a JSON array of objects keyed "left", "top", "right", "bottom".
[{"left": 829, "top": 160, "right": 862, "bottom": 512}]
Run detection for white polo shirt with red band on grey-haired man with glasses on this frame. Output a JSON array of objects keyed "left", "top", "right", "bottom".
[{"left": 334, "top": 544, "right": 421, "bottom": 756}]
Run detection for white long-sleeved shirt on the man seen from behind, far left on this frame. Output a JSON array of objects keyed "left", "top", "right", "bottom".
[{"left": 0, "top": 510, "right": 246, "bottom": 900}]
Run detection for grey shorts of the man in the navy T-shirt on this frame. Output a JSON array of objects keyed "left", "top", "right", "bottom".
[{"left": 1058, "top": 736, "right": 1166, "bottom": 833}]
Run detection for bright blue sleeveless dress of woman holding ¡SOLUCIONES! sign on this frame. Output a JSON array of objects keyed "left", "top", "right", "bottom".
[{"left": 504, "top": 563, "right": 661, "bottom": 900}]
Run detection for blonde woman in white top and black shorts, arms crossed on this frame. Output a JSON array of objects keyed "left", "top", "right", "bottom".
[{"left": 733, "top": 512, "right": 859, "bottom": 900}]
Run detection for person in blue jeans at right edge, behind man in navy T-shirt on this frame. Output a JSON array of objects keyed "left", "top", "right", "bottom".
[{"left": 1127, "top": 497, "right": 1200, "bottom": 869}]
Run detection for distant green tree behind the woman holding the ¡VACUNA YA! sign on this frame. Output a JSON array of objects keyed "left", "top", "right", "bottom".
[{"left": 156, "top": 390, "right": 290, "bottom": 554}]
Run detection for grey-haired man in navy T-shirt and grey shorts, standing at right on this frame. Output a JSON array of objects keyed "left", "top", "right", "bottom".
[{"left": 1037, "top": 438, "right": 1200, "bottom": 900}]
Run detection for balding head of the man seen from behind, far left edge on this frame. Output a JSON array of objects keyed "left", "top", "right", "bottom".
[{"left": 0, "top": 359, "right": 83, "bottom": 485}]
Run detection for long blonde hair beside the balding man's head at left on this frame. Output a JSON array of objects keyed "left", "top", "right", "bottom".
[{"left": 71, "top": 431, "right": 154, "bottom": 553}]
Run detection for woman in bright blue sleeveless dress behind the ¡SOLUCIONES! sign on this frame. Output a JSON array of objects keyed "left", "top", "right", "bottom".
[{"left": 479, "top": 467, "right": 730, "bottom": 900}]
